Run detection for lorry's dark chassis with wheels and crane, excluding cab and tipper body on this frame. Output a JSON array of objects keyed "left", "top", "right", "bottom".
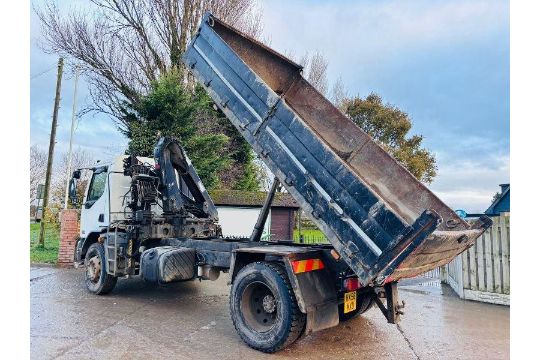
[{"left": 70, "top": 138, "right": 402, "bottom": 352}]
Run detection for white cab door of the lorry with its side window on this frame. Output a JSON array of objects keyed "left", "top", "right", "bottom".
[{"left": 80, "top": 166, "right": 109, "bottom": 237}]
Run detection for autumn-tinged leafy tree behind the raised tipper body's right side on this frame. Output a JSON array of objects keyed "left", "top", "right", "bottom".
[{"left": 339, "top": 93, "right": 437, "bottom": 183}]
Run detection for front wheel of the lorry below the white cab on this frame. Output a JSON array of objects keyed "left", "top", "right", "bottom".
[{"left": 84, "top": 243, "right": 118, "bottom": 295}]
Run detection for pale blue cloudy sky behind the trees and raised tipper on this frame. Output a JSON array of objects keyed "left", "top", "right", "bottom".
[{"left": 30, "top": 0, "right": 510, "bottom": 213}]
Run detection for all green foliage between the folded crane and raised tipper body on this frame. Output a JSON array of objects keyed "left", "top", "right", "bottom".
[{"left": 123, "top": 69, "right": 259, "bottom": 190}]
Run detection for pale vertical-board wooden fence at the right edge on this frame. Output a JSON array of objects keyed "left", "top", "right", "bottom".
[{"left": 441, "top": 213, "right": 510, "bottom": 305}]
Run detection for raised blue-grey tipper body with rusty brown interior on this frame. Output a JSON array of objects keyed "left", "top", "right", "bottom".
[{"left": 183, "top": 13, "right": 491, "bottom": 284}]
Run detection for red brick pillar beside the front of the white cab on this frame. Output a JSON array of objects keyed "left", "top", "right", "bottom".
[{"left": 58, "top": 209, "right": 79, "bottom": 267}]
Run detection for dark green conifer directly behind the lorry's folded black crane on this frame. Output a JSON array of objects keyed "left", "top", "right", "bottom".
[{"left": 123, "top": 70, "right": 231, "bottom": 189}]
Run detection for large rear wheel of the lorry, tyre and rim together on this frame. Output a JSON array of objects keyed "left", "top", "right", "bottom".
[{"left": 230, "top": 262, "right": 306, "bottom": 353}]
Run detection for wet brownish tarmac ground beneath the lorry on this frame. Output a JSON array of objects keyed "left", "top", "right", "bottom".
[{"left": 30, "top": 267, "right": 510, "bottom": 360}]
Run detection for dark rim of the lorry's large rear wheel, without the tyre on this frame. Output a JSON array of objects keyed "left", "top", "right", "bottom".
[{"left": 240, "top": 282, "right": 280, "bottom": 332}]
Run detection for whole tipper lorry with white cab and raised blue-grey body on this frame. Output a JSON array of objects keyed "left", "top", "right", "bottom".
[{"left": 69, "top": 13, "right": 491, "bottom": 352}]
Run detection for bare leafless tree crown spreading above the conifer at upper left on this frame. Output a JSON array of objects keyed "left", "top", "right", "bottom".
[{"left": 35, "top": 0, "right": 262, "bottom": 129}]
